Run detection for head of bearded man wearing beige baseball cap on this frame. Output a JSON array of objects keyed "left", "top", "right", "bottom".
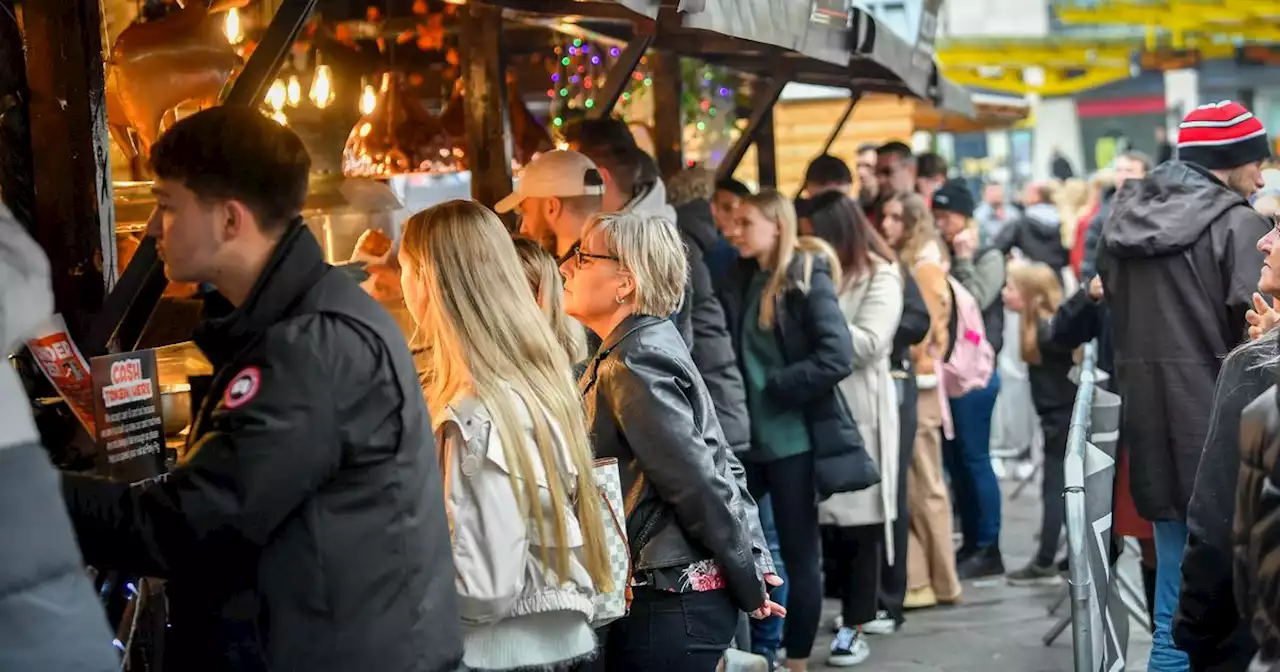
[{"left": 494, "top": 150, "right": 604, "bottom": 259}]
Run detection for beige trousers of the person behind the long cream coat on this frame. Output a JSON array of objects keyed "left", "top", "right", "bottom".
[{"left": 906, "top": 389, "right": 960, "bottom": 602}]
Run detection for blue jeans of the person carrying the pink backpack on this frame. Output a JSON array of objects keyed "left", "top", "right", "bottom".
[{"left": 942, "top": 372, "right": 1001, "bottom": 554}]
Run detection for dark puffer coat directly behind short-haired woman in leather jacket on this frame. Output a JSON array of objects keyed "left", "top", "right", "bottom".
[{"left": 676, "top": 200, "right": 751, "bottom": 453}]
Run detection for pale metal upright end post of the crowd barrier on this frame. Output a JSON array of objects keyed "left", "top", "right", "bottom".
[{"left": 1062, "top": 343, "right": 1097, "bottom": 672}]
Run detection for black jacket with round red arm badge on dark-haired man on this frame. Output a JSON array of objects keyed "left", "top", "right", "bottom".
[{"left": 64, "top": 223, "right": 462, "bottom": 672}]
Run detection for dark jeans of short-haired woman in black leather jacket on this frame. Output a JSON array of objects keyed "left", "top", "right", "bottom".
[{"left": 593, "top": 588, "right": 740, "bottom": 672}]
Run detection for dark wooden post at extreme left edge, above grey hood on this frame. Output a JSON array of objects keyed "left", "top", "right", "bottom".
[{"left": 0, "top": 0, "right": 36, "bottom": 230}]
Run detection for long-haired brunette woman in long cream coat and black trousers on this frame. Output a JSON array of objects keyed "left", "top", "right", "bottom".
[{"left": 801, "top": 192, "right": 905, "bottom": 667}]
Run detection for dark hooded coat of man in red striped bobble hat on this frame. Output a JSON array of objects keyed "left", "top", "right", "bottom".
[{"left": 1098, "top": 161, "right": 1271, "bottom": 521}]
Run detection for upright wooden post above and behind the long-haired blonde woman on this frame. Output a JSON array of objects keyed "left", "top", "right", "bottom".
[{"left": 458, "top": 3, "right": 512, "bottom": 211}]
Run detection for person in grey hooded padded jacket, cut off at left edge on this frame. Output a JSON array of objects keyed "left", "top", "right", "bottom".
[{"left": 0, "top": 204, "right": 120, "bottom": 672}]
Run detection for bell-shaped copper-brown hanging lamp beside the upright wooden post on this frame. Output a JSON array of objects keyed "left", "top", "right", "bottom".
[{"left": 342, "top": 72, "right": 465, "bottom": 178}]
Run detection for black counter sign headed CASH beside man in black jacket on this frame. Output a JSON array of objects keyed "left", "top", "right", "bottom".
[{"left": 90, "top": 349, "right": 164, "bottom": 483}]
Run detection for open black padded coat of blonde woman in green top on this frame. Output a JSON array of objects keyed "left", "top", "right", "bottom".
[{"left": 721, "top": 252, "right": 863, "bottom": 476}]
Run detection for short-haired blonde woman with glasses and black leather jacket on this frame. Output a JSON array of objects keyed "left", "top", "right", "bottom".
[{"left": 561, "top": 212, "right": 785, "bottom": 672}]
